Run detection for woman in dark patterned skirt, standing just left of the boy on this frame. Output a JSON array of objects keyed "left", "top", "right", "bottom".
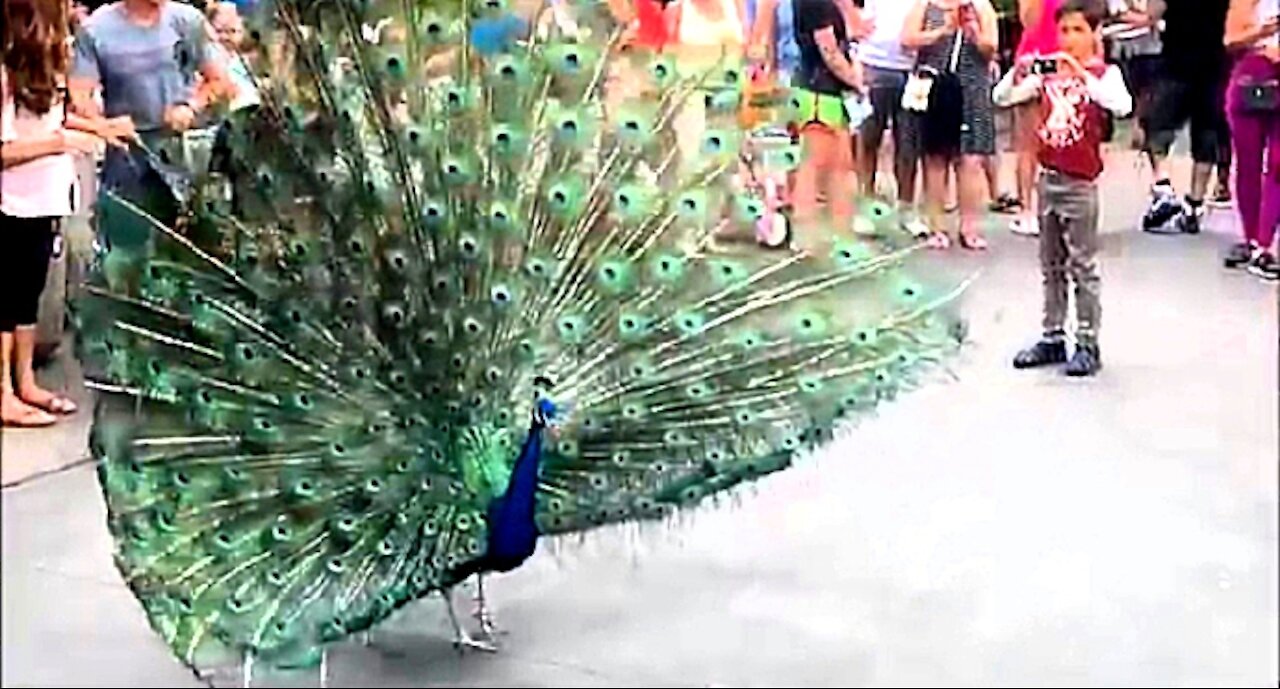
[{"left": 902, "top": 0, "right": 998, "bottom": 251}]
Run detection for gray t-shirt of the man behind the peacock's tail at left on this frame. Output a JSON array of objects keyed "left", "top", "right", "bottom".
[{"left": 72, "top": 0, "right": 215, "bottom": 132}]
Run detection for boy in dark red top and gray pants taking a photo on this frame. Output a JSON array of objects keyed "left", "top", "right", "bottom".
[{"left": 993, "top": 0, "right": 1133, "bottom": 377}]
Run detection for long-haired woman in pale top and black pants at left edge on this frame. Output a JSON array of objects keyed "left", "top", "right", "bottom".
[{"left": 0, "top": 0, "right": 127, "bottom": 428}]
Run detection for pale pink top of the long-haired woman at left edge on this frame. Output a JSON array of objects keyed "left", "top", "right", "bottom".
[{"left": 0, "top": 67, "right": 78, "bottom": 217}]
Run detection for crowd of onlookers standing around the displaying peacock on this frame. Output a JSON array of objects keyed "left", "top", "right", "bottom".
[{"left": 0, "top": 0, "right": 1280, "bottom": 426}]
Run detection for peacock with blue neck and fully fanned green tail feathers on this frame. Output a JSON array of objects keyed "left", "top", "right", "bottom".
[{"left": 74, "top": 0, "right": 964, "bottom": 669}]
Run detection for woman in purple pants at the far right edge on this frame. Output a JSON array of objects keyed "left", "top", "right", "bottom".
[{"left": 1224, "top": 0, "right": 1280, "bottom": 280}]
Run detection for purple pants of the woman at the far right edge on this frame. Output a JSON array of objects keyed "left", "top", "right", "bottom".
[{"left": 1226, "top": 55, "right": 1280, "bottom": 248}]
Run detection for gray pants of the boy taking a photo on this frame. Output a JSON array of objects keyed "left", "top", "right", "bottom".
[{"left": 1039, "top": 169, "right": 1102, "bottom": 345}]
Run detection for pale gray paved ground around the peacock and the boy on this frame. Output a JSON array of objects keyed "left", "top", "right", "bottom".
[{"left": 3, "top": 154, "right": 1280, "bottom": 686}]
